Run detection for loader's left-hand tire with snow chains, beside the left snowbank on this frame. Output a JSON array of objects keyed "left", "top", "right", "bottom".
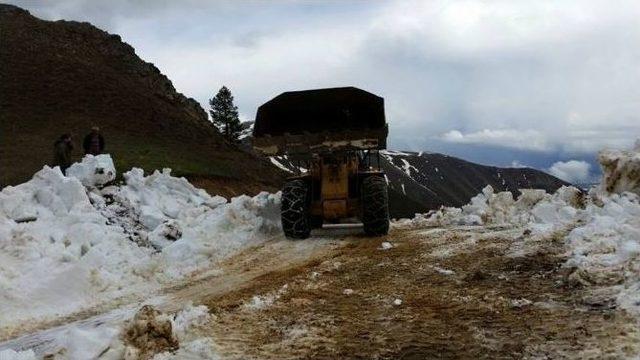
[{"left": 280, "top": 180, "right": 311, "bottom": 239}]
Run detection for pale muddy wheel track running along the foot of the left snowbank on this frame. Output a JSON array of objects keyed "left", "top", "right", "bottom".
[{"left": 0, "top": 233, "right": 342, "bottom": 355}]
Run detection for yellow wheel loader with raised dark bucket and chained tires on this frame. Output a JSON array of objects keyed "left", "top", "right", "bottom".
[{"left": 253, "top": 87, "right": 389, "bottom": 239}]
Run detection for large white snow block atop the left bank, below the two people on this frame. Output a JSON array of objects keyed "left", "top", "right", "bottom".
[{"left": 67, "top": 154, "right": 116, "bottom": 187}]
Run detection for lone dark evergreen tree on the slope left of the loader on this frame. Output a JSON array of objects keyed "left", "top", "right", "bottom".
[{"left": 209, "top": 86, "right": 242, "bottom": 142}]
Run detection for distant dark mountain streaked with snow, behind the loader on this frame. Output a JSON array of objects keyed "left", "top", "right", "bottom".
[{"left": 271, "top": 150, "right": 568, "bottom": 218}]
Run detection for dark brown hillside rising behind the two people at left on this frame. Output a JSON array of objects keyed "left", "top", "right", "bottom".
[{"left": 0, "top": 5, "right": 282, "bottom": 196}]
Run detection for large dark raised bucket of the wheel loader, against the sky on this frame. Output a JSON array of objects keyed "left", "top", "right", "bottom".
[{"left": 253, "top": 87, "right": 388, "bottom": 155}]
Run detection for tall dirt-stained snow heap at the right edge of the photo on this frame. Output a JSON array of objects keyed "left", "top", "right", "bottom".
[{"left": 565, "top": 142, "right": 640, "bottom": 315}]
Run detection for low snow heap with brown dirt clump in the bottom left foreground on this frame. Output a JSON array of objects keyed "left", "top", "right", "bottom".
[{"left": 19, "top": 304, "right": 218, "bottom": 360}]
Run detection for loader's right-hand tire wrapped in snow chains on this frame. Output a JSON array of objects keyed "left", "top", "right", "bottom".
[{"left": 362, "top": 176, "right": 389, "bottom": 236}]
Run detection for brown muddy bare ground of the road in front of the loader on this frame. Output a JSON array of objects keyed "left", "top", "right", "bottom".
[{"left": 204, "top": 229, "right": 640, "bottom": 359}]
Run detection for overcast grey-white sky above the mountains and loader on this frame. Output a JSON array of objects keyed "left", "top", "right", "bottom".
[{"left": 9, "top": 0, "right": 640, "bottom": 182}]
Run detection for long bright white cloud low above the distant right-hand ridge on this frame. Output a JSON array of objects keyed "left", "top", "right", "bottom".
[{"left": 440, "top": 129, "right": 553, "bottom": 151}]
